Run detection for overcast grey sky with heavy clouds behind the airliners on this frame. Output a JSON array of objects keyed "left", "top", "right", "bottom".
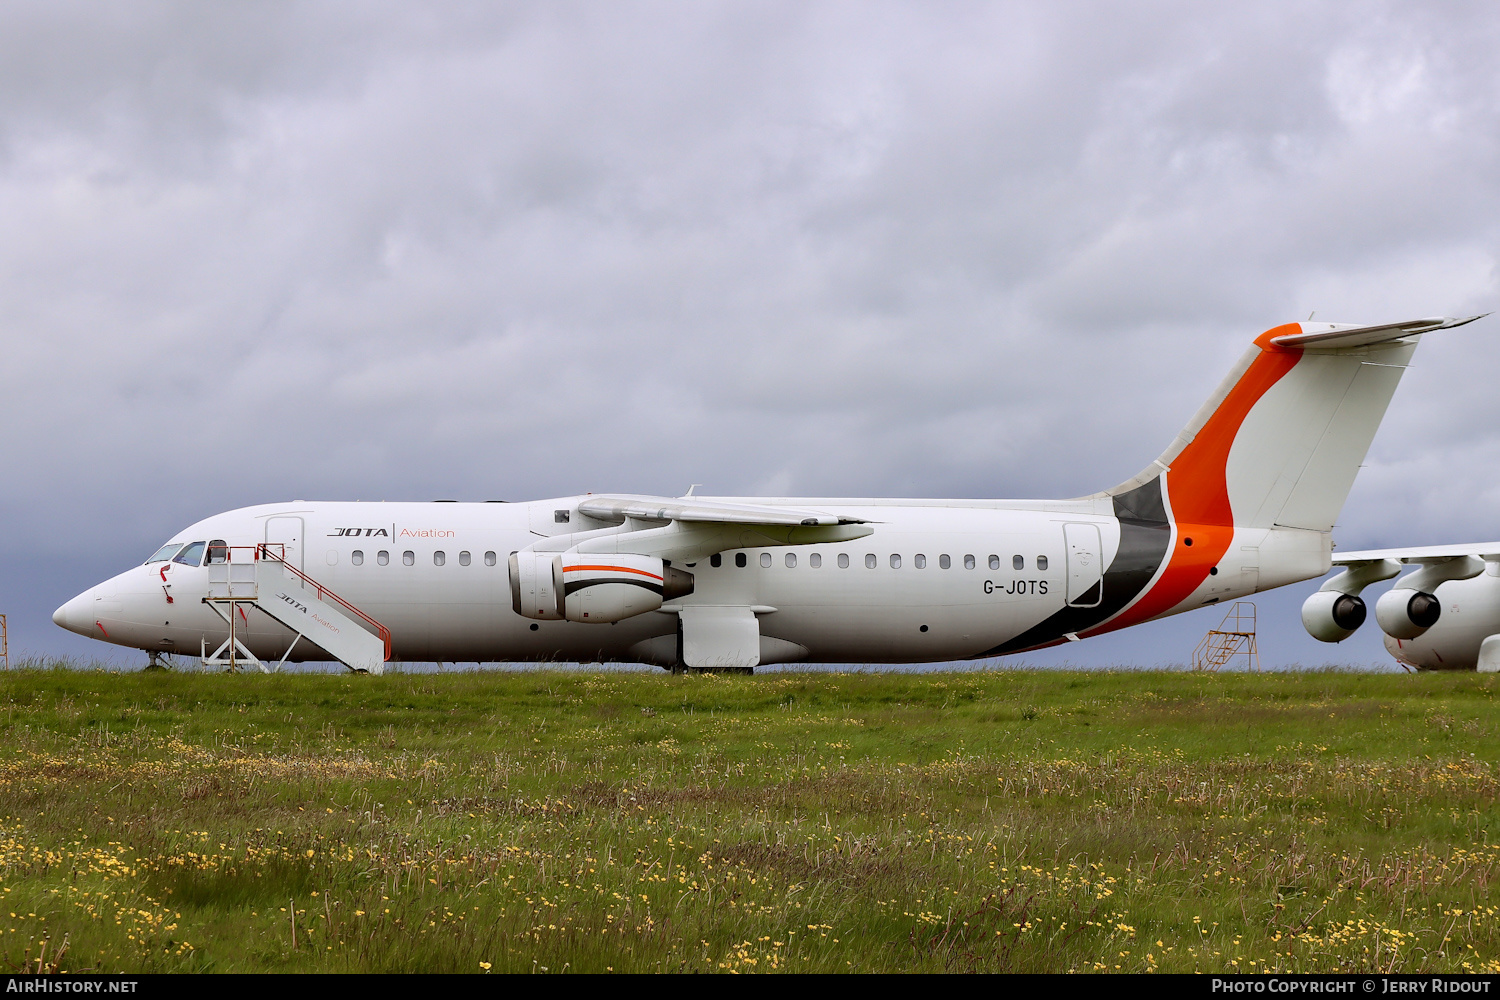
[{"left": 0, "top": 0, "right": 1500, "bottom": 663}]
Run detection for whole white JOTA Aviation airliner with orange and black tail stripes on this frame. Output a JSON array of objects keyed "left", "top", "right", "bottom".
[{"left": 53, "top": 316, "right": 1478, "bottom": 672}]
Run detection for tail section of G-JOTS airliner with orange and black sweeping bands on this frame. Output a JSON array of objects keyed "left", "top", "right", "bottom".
[{"left": 989, "top": 316, "right": 1479, "bottom": 654}]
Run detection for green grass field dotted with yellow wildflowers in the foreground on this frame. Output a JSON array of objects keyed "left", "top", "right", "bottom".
[{"left": 0, "top": 659, "right": 1500, "bottom": 973}]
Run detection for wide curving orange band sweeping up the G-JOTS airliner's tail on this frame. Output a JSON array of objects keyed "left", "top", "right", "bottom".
[{"left": 1083, "top": 322, "right": 1302, "bottom": 636}]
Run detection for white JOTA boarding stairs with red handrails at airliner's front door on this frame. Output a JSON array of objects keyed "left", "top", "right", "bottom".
[{"left": 200, "top": 544, "right": 390, "bottom": 673}]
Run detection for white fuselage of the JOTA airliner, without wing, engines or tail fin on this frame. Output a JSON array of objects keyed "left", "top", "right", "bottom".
[{"left": 46, "top": 498, "right": 1328, "bottom": 664}]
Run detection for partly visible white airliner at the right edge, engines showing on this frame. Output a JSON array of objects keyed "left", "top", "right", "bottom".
[{"left": 1302, "top": 541, "right": 1500, "bottom": 673}]
